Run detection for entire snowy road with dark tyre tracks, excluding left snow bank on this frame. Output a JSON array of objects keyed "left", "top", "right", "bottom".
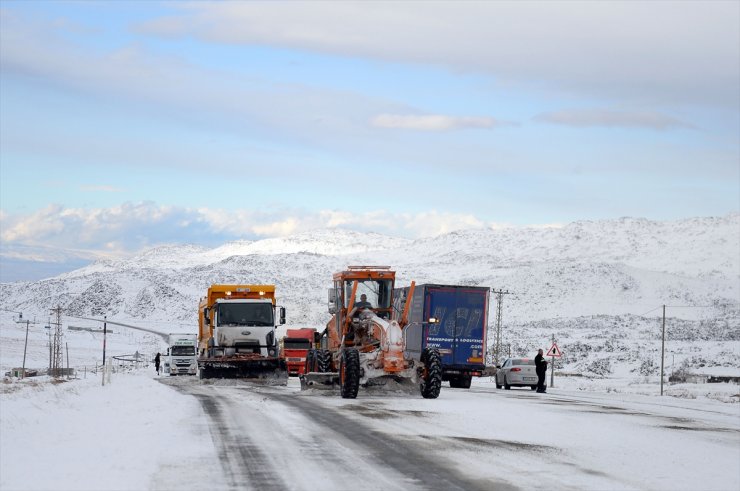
[{"left": 161, "top": 378, "right": 740, "bottom": 490}]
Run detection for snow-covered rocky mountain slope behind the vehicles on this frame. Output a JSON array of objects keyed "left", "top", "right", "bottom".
[{"left": 0, "top": 214, "right": 740, "bottom": 375}]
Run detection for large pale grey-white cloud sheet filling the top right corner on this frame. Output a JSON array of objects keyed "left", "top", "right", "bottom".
[{"left": 140, "top": 1, "right": 740, "bottom": 107}]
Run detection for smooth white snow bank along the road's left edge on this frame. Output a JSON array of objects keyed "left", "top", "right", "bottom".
[{"left": 0, "top": 369, "right": 225, "bottom": 491}]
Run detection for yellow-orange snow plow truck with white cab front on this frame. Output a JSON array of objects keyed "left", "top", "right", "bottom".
[{"left": 198, "top": 285, "right": 288, "bottom": 384}]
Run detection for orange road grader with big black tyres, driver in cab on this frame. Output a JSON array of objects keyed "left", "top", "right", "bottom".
[{"left": 300, "top": 266, "right": 442, "bottom": 399}]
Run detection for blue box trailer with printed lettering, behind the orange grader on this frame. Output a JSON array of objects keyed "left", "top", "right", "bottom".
[{"left": 394, "top": 284, "right": 490, "bottom": 389}]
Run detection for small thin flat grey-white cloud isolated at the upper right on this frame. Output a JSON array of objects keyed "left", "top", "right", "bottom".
[{"left": 535, "top": 109, "right": 693, "bottom": 130}]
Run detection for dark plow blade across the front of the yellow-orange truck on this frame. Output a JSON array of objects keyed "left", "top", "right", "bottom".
[{"left": 198, "top": 354, "right": 288, "bottom": 385}]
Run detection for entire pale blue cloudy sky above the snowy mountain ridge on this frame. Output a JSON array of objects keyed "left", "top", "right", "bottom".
[{"left": 0, "top": 0, "right": 740, "bottom": 281}]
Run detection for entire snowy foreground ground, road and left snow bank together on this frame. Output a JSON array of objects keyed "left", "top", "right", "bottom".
[{"left": 0, "top": 368, "right": 740, "bottom": 491}]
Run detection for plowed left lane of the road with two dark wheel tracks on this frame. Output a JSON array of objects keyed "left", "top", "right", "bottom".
[{"left": 163, "top": 378, "right": 506, "bottom": 490}]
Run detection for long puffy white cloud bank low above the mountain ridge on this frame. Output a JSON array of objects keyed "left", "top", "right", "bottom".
[{"left": 0, "top": 202, "right": 486, "bottom": 260}]
